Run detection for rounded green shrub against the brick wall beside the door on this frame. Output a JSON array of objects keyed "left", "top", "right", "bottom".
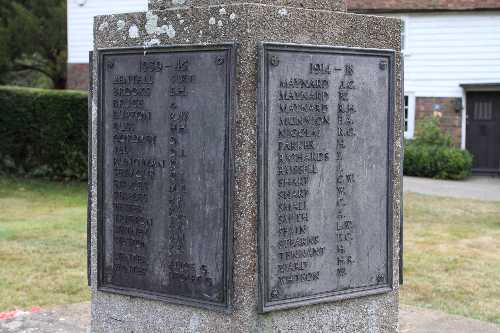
[{"left": 403, "top": 118, "right": 472, "bottom": 180}]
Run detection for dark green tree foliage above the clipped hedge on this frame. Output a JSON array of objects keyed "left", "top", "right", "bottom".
[{"left": 0, "top": 0, "right": 67, "bottom": 89}]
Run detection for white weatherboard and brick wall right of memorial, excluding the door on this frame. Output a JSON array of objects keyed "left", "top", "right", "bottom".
[{"left": 384, "top": 11, "right": 500, "bottom": 148}]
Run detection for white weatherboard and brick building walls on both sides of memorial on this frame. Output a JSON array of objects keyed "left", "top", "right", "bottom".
[{"left": 68, "top": 0, "right": 500, "bottom": 147}]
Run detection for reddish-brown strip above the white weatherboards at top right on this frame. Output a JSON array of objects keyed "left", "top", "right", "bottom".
[{"left": 347, "top": 0, "right": 500, "bottom": 12}]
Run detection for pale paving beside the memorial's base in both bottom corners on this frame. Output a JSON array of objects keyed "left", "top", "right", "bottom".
[{"left": 0, "top": 303, "right": 500, "bottom": 333}]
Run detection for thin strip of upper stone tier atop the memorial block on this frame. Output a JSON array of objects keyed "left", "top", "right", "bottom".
[{"left": 149, "top": 0, "right": 346, "bottom": 11}]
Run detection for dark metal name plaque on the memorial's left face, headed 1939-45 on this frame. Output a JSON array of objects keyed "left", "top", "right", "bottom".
[{"left": 98, "top": 45, "right": 234, "bottom": 310}]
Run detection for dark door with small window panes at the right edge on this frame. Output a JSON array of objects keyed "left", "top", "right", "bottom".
[{"left": 466, "top": 91, "right": 500, "bottom": 174}]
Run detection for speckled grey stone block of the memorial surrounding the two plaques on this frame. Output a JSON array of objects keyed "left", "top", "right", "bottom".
[{"left": 92, "top": 4, "right": 402, "bottom": 333}]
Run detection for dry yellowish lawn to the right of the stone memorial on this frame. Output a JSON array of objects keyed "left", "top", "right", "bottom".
[{"left": 401, "top": 194, "right": 500, "bottom": 324}]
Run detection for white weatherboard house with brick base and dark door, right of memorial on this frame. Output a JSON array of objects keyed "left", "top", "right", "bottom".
[{"left": 399, "top": 11, "right": 500, "bottom": 173}]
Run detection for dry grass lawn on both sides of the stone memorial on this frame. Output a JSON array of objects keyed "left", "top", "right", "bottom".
[{"left": 0, "top": 177, "right": 500, "bottom": 323}]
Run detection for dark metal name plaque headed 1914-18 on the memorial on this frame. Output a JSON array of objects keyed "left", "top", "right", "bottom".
[{"left": 258, "top": 44, "right": 394, "bottom": 312}]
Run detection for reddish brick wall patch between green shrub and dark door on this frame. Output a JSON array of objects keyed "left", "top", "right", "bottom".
[{"left": 415, "top": 97, "right": 462, "bottom": 147}]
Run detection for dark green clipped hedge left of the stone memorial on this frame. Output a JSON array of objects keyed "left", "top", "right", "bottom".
[{"left": 0, "top": 86, "right": 88, "bottom": 179}]
